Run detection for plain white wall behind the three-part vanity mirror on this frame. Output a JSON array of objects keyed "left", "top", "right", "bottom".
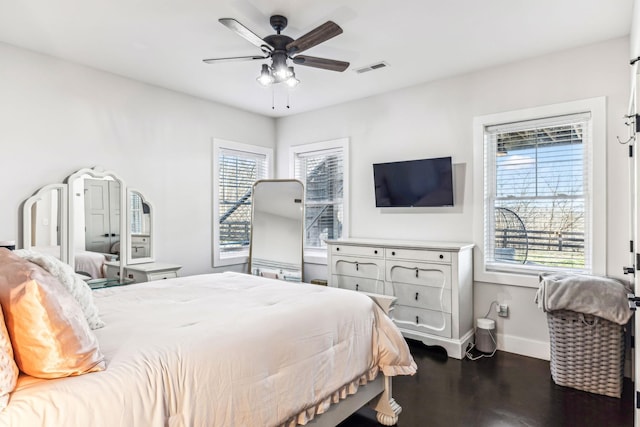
[{"left": 0, "top": 44, "right": 275, "bottom": 274}]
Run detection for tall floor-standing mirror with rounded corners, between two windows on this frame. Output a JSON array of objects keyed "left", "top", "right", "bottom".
[{"left": 249, "top": 179, "right": 304, "bottom": 282}]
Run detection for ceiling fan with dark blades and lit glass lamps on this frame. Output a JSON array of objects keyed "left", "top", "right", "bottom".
[{"left": 203, "top": 15, "right": 349, "bottom": 86}]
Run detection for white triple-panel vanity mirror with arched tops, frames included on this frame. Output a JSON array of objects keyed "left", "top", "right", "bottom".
[{"left": 22, "top": 168, "right": 153, "bottom": 279}]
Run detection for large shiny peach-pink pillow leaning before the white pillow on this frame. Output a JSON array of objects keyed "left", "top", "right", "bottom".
[{"left": 0, "top": 248, "right": 105, "bottom": 378}]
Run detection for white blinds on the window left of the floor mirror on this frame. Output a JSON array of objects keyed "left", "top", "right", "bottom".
[{"left": 218, "top": 148, "right": 268, "bottom": 253}]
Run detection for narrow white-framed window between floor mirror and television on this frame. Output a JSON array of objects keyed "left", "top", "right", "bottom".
[{"left": 291, "top": 138, "right": 349, "bottom": 260}]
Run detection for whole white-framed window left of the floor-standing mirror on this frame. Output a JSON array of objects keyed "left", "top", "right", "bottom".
[{"left": 213, "top": 139, "right": 272, "bottom": 267}]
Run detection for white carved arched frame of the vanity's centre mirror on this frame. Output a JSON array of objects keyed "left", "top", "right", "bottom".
[{"left": 64, "top": 166, "right": 129, "bottom": 277}]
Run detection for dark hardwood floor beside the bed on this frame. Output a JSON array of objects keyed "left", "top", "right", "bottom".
[{"left": 339, "top": 341, "right": 633, "bottom": 427}]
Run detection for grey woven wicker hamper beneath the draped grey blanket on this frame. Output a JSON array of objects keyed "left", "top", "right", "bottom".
[{"left": 547, "top": 310, "right": 624, "bottom": 397}]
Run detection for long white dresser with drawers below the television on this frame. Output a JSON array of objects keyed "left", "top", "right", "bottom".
[{"left": 327, "top": 239, "right": 473, "bottom": 359}]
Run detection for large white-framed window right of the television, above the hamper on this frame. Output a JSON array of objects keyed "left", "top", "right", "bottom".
[{"left": 476, "top": 101, "right": 605, "bottom": 288}]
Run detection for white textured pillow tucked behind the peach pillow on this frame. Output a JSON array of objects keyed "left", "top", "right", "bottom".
[{"left": 13, "top": 249, "right": 104, "bottom": 329}]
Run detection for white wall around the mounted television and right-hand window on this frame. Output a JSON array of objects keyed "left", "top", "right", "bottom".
[{"left": 276, "top": 38, "right": 630, "bottom": 358}]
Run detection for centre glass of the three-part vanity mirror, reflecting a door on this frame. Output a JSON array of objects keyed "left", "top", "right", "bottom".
[{"left": 84, "top": 178, "right": 120, "bottom": 254}]
